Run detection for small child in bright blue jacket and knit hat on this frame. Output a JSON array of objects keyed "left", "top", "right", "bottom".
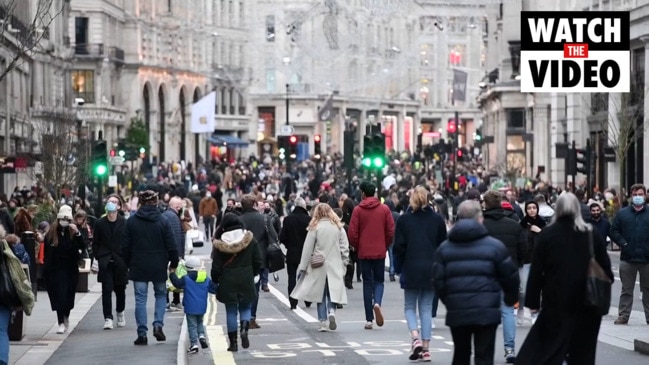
[{"left": 169, "top": 256, "right": 210, "bottom": 354}]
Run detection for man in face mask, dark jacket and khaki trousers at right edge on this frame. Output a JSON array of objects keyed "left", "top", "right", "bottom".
[{"left": 610, "top": 184, "right": 649, "bottom": 325}]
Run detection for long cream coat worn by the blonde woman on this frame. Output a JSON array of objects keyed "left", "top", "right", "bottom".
[{"left": 291, "top": 219, "right": 349, "bottom": 304}]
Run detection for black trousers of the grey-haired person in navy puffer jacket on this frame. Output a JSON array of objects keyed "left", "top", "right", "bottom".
[{"left": 451, "top": 325, "right": 498, "bottom": 365}]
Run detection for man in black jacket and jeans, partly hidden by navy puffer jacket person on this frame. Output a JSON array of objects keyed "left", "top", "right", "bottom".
[{"left": 482, "top": 190, "right": 527, "bottom": 364}]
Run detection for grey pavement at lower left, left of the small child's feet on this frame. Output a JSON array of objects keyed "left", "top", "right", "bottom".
[{"left": 9, "top": 275, "right": 186, "bottom": 365}]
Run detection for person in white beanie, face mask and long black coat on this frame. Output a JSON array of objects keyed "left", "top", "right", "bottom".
[{"left": 43, "top": 205, "right": 83, "bottom": 334}]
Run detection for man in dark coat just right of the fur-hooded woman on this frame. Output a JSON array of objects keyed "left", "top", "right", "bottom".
[{"left": 239, "top": 194, "right": 273, "bottom": 329}]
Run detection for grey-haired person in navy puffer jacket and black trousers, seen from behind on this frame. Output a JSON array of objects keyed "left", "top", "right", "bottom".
[{"left": 433, "top": 200, "right": 519, "bottom": 364}]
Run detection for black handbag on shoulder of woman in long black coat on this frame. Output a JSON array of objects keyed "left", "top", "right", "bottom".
[{"left": 584, "top": 231, "right": 613, "bottom": 316}]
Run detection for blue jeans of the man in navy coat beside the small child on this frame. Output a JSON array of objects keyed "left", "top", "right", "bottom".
[{"left": 133, "top": 281, "right": 167, "bottom": 336}]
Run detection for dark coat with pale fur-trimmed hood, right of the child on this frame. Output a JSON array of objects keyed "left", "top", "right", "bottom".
[{"left": 211, "top": 229, "right": 262, "bottom": 303}]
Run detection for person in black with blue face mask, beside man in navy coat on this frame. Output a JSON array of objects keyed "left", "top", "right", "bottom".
[{"left": 92, "top": 198, "right": 128, "bottom": 330}]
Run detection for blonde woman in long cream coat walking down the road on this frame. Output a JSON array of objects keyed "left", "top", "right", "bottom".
[{"left": 291, "top": 203, "right": 349, "bottom": 332}]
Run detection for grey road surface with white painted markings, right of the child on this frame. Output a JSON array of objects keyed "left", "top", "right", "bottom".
[{"left": 188, "top": 240, "right": 649, "bottom": 365}]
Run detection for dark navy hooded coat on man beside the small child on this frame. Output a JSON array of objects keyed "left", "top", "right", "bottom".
[{"left": 122, "top": 205, "right": 178, "bottom": 282}]
